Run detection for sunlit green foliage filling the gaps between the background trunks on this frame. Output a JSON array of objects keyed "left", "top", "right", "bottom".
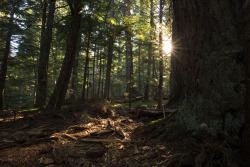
[{"left": 0, "top": 0, "right": 173, "bottom": 108}]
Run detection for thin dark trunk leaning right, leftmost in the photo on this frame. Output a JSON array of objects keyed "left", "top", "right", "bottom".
[{"left": 0, "top": 0, "right": 15, "bottom": 111}]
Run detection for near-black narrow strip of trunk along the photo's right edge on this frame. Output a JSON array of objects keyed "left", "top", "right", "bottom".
[{"left": 242, "top": 0, "right": 250, "bottom": 167}]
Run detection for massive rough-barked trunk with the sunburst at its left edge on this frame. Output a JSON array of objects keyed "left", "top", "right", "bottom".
[{"left": 170, "top": 0, "right": 245, "bottom": 135}]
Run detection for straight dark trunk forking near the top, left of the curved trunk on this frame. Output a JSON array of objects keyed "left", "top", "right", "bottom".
[{"left": 36, "top": 0, "right": 56, "bottom": 108}]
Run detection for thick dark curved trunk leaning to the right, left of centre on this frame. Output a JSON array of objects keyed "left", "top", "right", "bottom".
[{"left": 47, "top": 0, "right": 82, "bottom": 111}]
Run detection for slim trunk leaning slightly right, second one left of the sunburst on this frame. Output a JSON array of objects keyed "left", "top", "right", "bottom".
[{"left": 144, "top": 0, "right": 154, "bottom": 100}]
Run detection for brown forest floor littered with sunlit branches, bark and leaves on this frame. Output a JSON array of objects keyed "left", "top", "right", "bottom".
[{"left": 0, "top": 100, "right": 243, "bottom": 167}]
